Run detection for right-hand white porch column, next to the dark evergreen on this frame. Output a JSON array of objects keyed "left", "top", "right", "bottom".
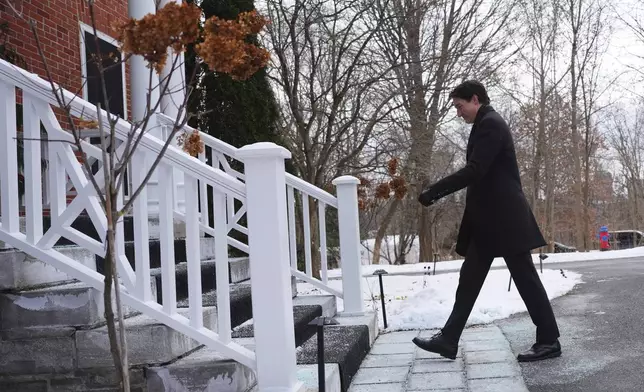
[{"left": 161, "top": 0, "right": 186, "bottom": 212}]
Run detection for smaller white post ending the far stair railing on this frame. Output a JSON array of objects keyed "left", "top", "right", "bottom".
[{"left": 333, "top": 176, "right": 365, "bottom": 315}]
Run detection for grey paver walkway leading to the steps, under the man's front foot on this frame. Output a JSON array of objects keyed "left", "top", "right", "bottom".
[{"left": 349, "top": 326, "right": 528, "bottom": 392}]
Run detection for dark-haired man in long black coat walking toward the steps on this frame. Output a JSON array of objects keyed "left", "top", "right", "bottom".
[{"left": 414, "top": 80, "right": 561, "bottom": 362}]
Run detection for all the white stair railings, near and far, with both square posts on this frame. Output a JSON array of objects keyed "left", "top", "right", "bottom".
[{"left": 0, "top": 60, "right": 363, "bottom": 392}]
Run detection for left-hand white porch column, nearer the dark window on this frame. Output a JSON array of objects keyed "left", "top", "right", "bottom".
[{"left": 128, "top": 0, "right": 163, "bottom": 215}]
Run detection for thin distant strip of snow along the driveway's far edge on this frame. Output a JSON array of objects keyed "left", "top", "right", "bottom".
[{"left": 328, "top": 247, "right": 644, "bottom": 278}]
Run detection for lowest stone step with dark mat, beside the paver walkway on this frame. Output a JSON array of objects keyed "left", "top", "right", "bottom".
[{"left": 297, "top": 312, "right": 378, "bottom": 392}]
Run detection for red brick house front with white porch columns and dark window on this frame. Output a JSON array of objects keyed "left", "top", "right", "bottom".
[{"left": 0, "top": 0, "right": 185, "bottom": 211}]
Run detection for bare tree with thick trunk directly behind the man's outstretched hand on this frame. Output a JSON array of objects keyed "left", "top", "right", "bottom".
[{"left": 372, "top": 0, "right": 514, "bottom": 261}]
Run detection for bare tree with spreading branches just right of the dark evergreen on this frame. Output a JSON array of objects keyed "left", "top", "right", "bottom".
[{"left": 267, "top": 0, "right": 398, "bottom": 277}]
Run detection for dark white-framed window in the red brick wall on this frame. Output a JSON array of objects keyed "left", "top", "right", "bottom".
[{"left": 83, "top": 31, "right": 125, "bottom": 118}]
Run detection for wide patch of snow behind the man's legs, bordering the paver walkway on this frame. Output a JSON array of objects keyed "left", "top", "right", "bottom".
[{"left": 298, "top": 270, "right": 581, "bottom": 331}]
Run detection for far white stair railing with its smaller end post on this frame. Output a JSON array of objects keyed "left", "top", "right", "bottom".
[{"left": 158, "top": 114, "right": 364, "bottom": 314}]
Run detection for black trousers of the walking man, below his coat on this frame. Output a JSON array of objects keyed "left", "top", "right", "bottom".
[{"left": 442, "top": 246, "right": 559, "bottom": 343}]
